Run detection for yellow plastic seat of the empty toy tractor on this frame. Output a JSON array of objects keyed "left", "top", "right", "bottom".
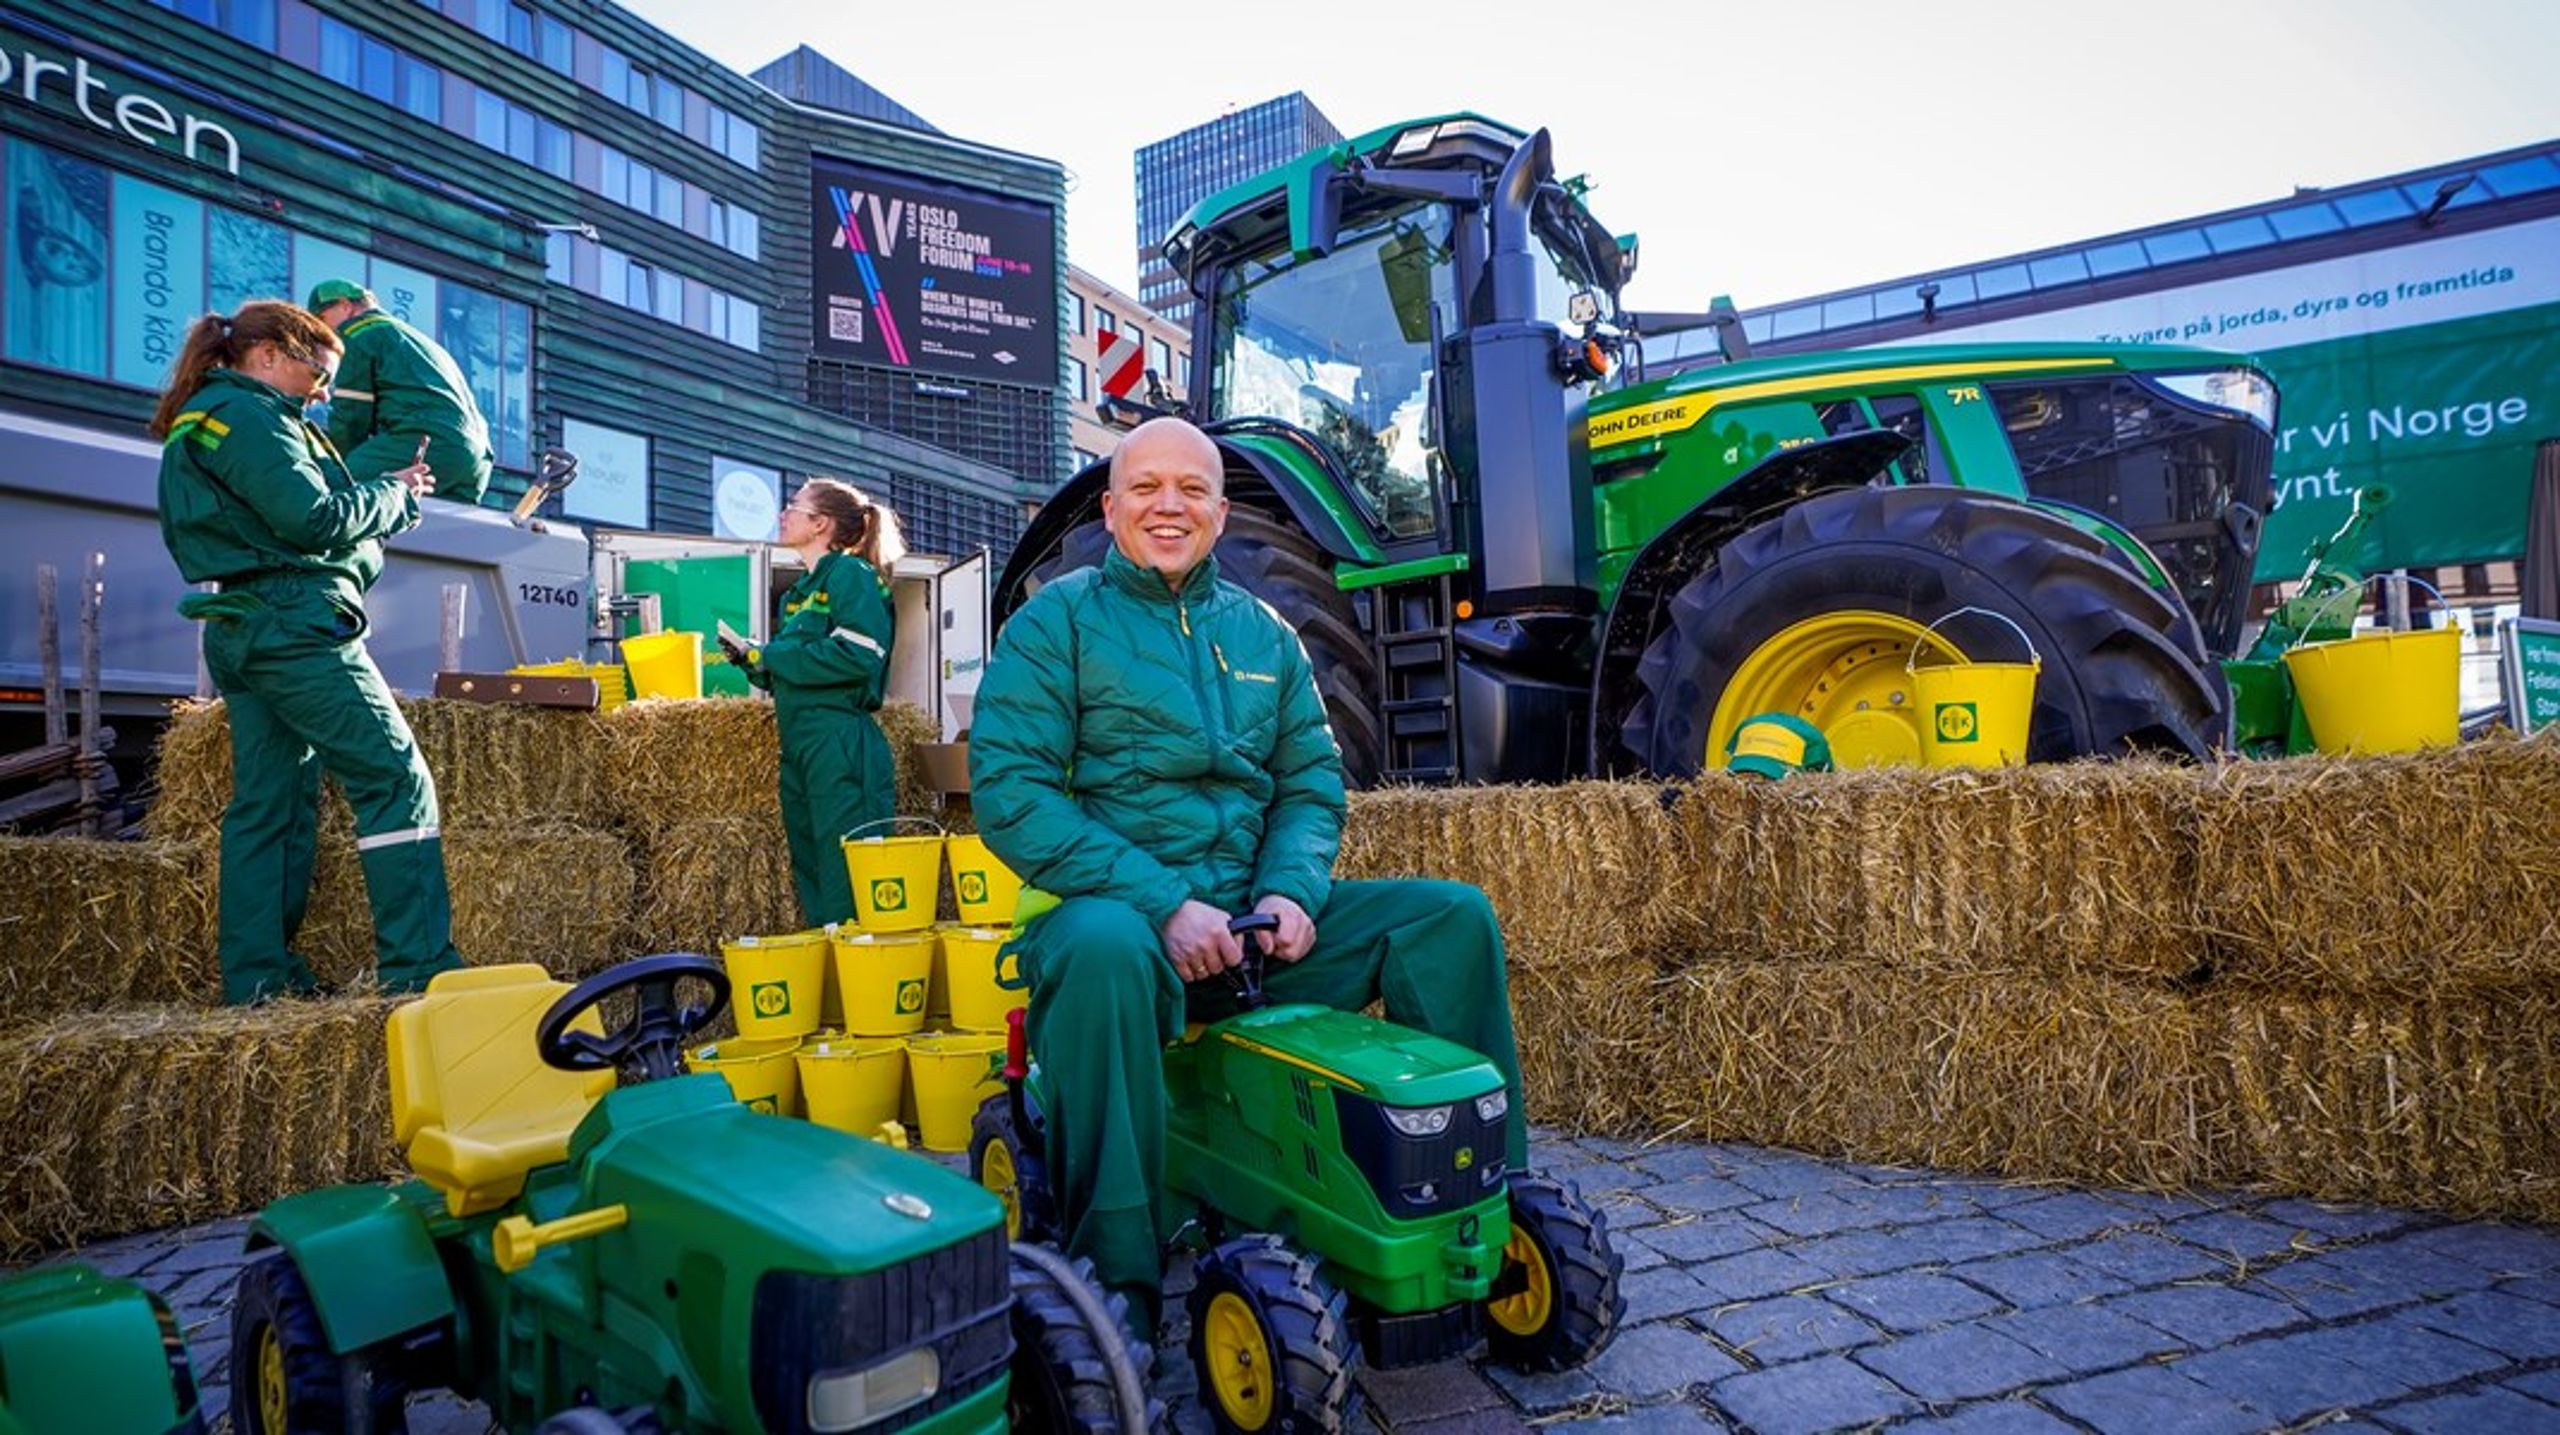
[{"left": 389, "top": 962, "right": 614, "bottom": 1215}]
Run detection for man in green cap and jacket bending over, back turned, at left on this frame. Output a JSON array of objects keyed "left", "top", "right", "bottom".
[{"left": 310, "top": 279, "right": 497, "bottom": 504}]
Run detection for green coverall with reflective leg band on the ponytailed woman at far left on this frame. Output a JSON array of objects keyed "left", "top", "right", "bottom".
[{"left": 159, "top": 368, "right": 461, "bottom": 1003}]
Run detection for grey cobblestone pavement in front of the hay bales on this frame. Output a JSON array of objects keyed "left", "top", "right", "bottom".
[{"left": 20, "top": 1136, "right": 2560, "bottom": 1435}]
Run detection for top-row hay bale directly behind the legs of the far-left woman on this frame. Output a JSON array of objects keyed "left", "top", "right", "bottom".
[{"left": 146, "top": 698, "right": 609, "bottom": 842}]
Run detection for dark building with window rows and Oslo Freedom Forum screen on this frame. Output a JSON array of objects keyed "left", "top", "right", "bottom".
[{"left": 0, "top": 0, "right": 1068, "bottom": 553}]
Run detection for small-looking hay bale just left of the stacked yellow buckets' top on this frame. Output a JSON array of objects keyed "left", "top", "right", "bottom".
[{"left": 630, "top": 803, "right": 801, "bottom": 954}]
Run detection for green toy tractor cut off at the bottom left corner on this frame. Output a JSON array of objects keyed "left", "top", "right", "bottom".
[{"left": 0, "top": 1266, "right": 205, "bottom": 1435}]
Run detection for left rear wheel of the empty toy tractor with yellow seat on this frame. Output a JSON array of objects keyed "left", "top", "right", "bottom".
[{"left": 230, "top": 1251, "right": 410, "bottom": 1435}]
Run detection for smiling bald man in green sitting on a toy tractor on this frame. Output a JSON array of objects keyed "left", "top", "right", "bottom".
[{"left": 970, "top": 420, "right": 1528, "bottom": 1335}]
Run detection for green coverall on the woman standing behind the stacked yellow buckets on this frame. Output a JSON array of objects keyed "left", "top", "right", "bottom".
[{"left": 748, "top": 553, "right": 899, "bottom": 926}]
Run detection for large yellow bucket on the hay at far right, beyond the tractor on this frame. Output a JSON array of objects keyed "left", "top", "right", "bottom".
[{"left": 2284, "top": 627, "right": 2463, "bottom": 752}]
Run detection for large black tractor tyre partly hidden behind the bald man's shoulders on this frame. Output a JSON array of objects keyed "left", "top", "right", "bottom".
[{"left": 1032, "top": 504, "right": 1385, "bottom": 788}]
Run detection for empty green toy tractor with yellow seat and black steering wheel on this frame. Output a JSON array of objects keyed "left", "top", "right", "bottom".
[{"left": 230, "top": 954, "right": 1155, "bottom": 1435}]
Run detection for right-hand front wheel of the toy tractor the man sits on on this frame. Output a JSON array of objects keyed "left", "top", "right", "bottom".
[{"left": 1485, "top": 1177, "right": 1626, "bottom": 1371}]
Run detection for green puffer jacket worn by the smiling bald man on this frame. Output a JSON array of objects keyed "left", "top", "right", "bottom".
[{"left": 968, "top": 547, "right": 1341, "bottom": 929}]
